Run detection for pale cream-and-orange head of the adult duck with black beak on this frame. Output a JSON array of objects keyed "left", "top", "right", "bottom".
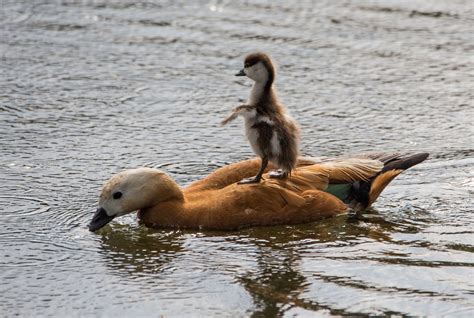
[{"left": 89, "top": 168, "right": 183, "bottom": 232}]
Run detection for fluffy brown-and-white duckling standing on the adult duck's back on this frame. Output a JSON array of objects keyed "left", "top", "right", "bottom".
[{"left": 221, "top": 52, "right": 300, "bottom": 184}]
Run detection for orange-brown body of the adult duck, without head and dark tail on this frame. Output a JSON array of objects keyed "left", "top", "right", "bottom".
[{"left": 136, "top": 159, "right": 383, "bottom": 230}]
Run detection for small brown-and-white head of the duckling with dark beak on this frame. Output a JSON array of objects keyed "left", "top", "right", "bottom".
[{"left": 235, "top": 52, "right": 275, "bottom": 83}]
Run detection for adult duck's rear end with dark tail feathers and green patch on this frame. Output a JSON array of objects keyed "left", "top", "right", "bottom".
[{"left": 351, "top": 153, "right": 429, "bottom": 209}]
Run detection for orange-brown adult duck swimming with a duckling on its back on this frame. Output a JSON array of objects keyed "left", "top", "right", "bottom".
[{"left": 89, "top": 153, "right": 428, "bottom": 231}]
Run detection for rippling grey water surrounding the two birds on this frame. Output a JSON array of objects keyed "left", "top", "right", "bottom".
[{"left": 0, "top": 0, "right": 474, "bottom": 317}]
